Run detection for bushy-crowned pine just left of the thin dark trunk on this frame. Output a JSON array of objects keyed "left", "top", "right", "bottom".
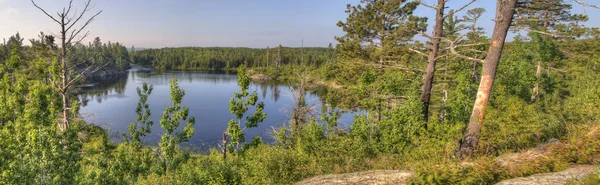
[{"left": 336, "top": 0, "right": 427, "bottom": 120}]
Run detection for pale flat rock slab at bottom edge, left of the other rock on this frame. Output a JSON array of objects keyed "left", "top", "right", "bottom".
[{"left": 296, "top": 170, "right": 415, "bottom": 185}]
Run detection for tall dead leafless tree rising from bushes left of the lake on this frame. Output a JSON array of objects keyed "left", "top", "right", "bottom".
[{"left": 31, "top": 0, "right": 103, "bottom": 132}]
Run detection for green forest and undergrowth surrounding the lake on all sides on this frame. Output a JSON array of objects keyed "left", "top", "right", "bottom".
[{"left": 0, "top": 0, "right": 600, "bottom": 184}]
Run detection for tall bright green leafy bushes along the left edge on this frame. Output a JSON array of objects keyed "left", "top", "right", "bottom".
[{"left": 0, "top": 37, "right": 82, "bottom": 184}]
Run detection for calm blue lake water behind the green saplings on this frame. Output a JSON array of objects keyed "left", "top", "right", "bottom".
[{"left": 79, "top": 69, "right": 354, "bottom": 149}]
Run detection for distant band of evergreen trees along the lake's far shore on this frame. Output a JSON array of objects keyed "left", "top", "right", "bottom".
[{"left": 131, "top": 45, "right": 335, "bottom": 70}]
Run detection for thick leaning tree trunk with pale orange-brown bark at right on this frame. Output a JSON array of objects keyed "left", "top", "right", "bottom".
[{"left": 460, "top": 0, "right": 517, "bottom": 158}]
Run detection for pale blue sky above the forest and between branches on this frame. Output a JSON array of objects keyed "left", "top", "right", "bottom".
[{"left": 0, "top": 0, "right": 600, "bottom": 48}]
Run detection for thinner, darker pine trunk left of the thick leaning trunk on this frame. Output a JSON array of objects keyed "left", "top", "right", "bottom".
[{"left": 421, "top": 0, "right": 446, "bottom": 122}]
